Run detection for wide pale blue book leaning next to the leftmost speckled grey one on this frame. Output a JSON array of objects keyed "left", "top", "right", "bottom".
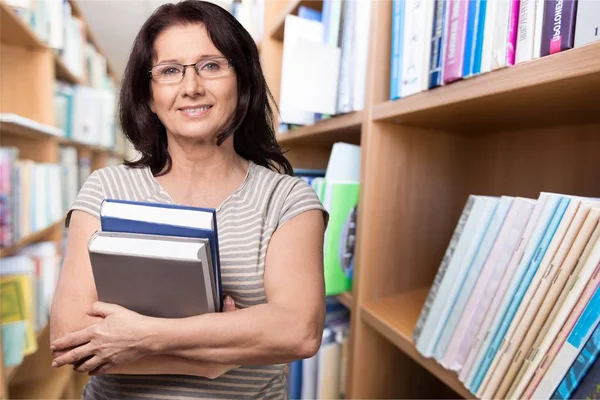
[{"left": 417, "top": 196, "right": 500, "bottom": 357}]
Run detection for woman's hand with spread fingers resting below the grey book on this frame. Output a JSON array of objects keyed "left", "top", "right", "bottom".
[{"left": 50, "top": 302, "right": 152, "bottom": 373}]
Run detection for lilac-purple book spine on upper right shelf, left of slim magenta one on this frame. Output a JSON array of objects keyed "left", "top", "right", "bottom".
[{"left": 444, "top": 0, "right": 469, "bottom": 83}]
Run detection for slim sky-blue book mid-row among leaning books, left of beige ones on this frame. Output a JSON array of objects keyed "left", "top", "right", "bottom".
[{"left": 468, "top": 196, "right": 571, "bottom": 393}]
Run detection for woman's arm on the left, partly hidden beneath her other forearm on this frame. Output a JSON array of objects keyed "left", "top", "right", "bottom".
[{"left": 50, "top": 210, "right": 234, "bottom": 378}]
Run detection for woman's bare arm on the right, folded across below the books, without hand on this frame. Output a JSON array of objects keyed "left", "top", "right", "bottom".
[{"left": 147, "top": 211, "right": 325, "bottom": 365}]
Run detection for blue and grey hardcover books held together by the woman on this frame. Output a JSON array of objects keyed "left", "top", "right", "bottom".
[{"left": 88, "top": 199, "right": 223, "bottom": 318}]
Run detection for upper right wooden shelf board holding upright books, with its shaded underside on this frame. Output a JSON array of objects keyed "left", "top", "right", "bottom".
[{"left": 373, "top": 42, "right": 600, "bottom": 131}]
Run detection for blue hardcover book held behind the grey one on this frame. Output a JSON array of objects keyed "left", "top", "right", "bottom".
[{"left": 100, "top": 199, "right": 223, "bottom": 310}]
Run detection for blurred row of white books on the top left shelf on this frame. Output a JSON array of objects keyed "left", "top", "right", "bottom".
[{"left": 5, "top": 0, "right": 112, "bottom": 89}]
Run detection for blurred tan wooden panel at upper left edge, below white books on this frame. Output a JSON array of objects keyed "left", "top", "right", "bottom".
[{"left": 0, "top": 45, "right": 54, "bottom": 126}]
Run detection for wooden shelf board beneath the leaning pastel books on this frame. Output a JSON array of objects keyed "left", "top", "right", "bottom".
[{"left": 361, "top": 288, "right": 474, "bottom": 399}]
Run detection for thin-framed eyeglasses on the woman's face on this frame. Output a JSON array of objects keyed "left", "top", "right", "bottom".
[{"left": 148, "top": 57, "right": 233, "bottom": 83}]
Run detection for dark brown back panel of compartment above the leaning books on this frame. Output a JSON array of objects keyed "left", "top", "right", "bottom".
[{"left": 465, "top": 124, "right": 600, "bottom": 198}]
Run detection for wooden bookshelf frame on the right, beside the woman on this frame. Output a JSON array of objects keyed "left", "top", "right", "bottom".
[{"left": 261, "top": 0, "right": 600, "bottom": 398}]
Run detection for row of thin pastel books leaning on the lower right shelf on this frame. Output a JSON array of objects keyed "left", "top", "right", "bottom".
[{"left": 414, "top": 192, "right": 600, "bottom": 399}]
